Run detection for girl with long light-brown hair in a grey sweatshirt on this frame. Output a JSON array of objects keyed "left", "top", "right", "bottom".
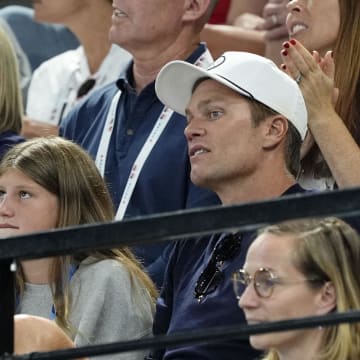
[{"left": 0, "top": 137, "right": 157, "bottom": 359}]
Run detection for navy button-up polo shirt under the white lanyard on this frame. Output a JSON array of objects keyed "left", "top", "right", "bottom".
[{"left": 60, "top": 44, "right": 219, "bottom": 284}]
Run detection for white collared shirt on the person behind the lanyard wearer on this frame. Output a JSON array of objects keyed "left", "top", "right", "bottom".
[{"left": 26, "top": 45, "right": 131, "bottom": 125}]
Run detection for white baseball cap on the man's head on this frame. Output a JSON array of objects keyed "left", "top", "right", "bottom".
[{"left": 155, "top": 51, "right": 307, "bottom": 139}]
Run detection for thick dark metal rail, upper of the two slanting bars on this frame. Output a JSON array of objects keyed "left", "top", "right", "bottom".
[{"left": 0, "top": 188, "right": 360, "bottom": 260}]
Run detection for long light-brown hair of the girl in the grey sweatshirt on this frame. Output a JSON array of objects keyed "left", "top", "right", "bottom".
[{"left": 0, "top": 137, "right": 157, "bottom": 333}]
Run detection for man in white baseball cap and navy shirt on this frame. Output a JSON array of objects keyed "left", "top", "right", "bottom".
[{"left": 149, "top": 52, "right": 307, "bottom": 360}]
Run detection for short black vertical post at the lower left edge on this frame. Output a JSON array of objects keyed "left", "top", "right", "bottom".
[{"left": 0, "top": 260, "right": 15, "bottom": 357}]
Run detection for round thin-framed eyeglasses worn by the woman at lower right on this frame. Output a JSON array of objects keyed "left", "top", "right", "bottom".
[{"left": 233, "top": 268, "right": 324, "bottom": 299}]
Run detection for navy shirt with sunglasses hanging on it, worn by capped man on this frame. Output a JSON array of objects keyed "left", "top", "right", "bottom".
[{"left": 149, "top": 184, "right": 304, "bottom": 360}]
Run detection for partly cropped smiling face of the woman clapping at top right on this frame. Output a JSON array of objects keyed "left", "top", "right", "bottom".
[{"left": 286, "top": 0, "right": 340, "bottom": 54}]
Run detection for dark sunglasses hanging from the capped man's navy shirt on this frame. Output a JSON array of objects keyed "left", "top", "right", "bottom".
[{"left": 194, "top": 233, "right": 242, "bottom": 303}]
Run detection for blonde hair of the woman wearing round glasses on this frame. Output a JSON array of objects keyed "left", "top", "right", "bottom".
[{"left": 261, "top": 218, "right": 360, "bottom": 360}]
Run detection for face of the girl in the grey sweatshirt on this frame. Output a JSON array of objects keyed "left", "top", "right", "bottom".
[{"left": 0, "top": 169, "right": 59, "bottom": 238}]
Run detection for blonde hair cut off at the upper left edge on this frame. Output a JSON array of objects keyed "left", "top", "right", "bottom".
[{"left": 0, "top": 29, "right": 23, "bottom": 134}]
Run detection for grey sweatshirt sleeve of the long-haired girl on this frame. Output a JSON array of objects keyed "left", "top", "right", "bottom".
[{"left": 70, "top": 260, "right": 153, "bottom": 360}]
